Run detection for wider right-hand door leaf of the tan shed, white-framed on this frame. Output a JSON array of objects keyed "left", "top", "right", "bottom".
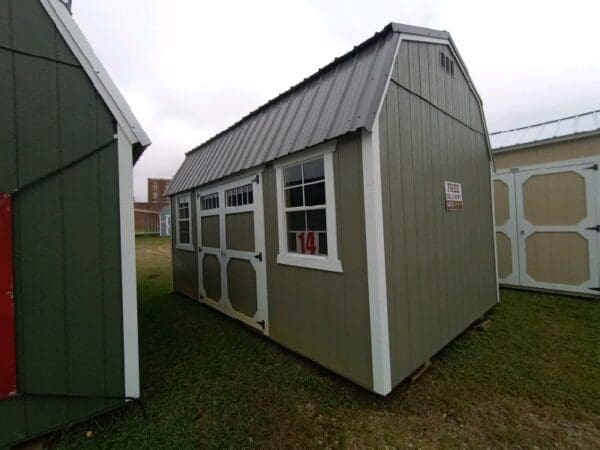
[{"left": 515, "top": 162, "right": 600, "bottom": 293}]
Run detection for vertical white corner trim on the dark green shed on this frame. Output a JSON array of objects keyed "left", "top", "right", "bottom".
[{"left": 117, "top": 125, "right": 140, "bottom": 398}]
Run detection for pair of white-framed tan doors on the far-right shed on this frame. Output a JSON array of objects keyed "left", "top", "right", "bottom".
[{"left": 494, "top": 160, "right": 600, "bottom": 294}]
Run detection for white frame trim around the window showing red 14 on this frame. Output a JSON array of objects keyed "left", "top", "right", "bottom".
[{"left": 274, "top": 141, "right": 343, "bottom": 272}]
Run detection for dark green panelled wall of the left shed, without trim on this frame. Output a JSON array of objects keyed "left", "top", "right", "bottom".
[{"left": 0, "top": 0, "right": 124, "bottom": 447}]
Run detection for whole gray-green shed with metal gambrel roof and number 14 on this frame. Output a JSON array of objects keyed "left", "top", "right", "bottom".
[{"left": 167, "top": 23, "right": 498, "bottom": 395}]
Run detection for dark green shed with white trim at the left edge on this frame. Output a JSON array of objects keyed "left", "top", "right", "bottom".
[{"left": 0, "top": 0, "right": 150, "bottom": 448}]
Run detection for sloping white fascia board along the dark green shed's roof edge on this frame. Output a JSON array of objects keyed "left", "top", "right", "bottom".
[{"left": 40, "top": 0, "right": 151, "bottom": 148}]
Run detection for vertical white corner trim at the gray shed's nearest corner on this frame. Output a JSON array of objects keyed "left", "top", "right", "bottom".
[{"left": 361, "top": 122, "right": 392, "bottom": 395}]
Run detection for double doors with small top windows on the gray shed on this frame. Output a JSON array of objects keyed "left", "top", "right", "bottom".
[{"left": 196, "top": 174, "right": 269, "bottom": 335}]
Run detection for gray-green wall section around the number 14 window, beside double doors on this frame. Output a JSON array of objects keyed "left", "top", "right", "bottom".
[{"left": 263, "top": 133, "right": 373, "bottom": 389}]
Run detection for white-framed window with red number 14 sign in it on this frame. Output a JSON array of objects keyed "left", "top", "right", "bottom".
[{"left": 276, "top": 143, "right": 342, "bottom": 272}]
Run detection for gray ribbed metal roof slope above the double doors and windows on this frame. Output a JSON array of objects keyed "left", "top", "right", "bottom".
[{"left": 167, "top": 23, "right": 450, "bottom": 195}]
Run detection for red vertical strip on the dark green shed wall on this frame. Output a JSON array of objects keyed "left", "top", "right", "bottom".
[{"left": 0, "top": 193, "right": 17, "bottom": 399}]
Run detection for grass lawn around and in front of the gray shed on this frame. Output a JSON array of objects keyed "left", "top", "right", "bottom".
[{"left": 58, "top": 238, "right": 600, "bottom": 449}]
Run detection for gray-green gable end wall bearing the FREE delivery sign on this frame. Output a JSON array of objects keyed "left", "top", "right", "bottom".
[{"left": 379, "top": 42, "right": 497, "bottom": 386}]
